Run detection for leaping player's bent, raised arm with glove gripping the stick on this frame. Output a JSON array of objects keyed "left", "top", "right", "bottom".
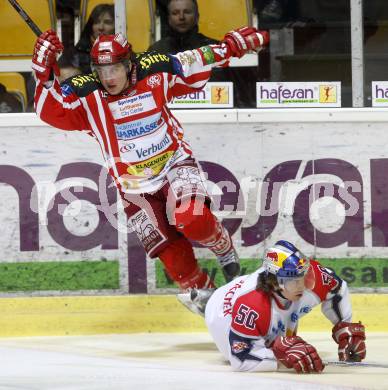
[{"left": 32, "top": 30, "right": 90, "bottom": 130}]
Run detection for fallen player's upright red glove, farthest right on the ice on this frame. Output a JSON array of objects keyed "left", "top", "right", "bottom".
[{"left": 332, "top": 322, "right": 366, "bottom": 362}]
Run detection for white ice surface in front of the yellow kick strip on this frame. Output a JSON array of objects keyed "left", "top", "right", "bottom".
[{"left": 0, "top": 333, "right": 388, "bottom": 390}]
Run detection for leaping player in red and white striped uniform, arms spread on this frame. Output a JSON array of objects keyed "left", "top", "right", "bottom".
[{"left": 32, "top": 27, "right": 268, "bottom": 289}]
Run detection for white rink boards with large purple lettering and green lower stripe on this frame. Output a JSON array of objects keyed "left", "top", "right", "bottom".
[{"left": 0, "top": 108, "right": 388, "bottom": 296}]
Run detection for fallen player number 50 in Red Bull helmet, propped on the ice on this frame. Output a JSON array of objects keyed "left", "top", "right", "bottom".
[{"left": 205, "top": 241, "right": 366, "bottom": 373}]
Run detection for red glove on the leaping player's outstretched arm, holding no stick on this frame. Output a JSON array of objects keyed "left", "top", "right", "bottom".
[{"left": 221, "top": 27, "right": 269, "bottom": 58}]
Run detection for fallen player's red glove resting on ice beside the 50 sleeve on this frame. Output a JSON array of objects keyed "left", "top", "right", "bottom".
[{"left": 272, "top": 336, "right": 324, "bottom": 373}]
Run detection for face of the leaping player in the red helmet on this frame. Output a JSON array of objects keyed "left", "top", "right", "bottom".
[{"left": 95, "top": 62, "right": 129, "bottom": 95}]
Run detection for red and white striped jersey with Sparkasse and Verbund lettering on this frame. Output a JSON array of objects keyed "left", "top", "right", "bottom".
[{"left": 35, "top": 45, "right": 228, "bottom": 193}]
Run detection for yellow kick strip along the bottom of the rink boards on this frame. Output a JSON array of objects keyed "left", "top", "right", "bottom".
[{"left": 0, "top": 294, "right": 388, "bottom": 337}]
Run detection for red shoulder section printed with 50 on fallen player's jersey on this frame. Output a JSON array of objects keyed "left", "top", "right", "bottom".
[{"left": 231, "top": 290, "right": 271, "bottom": 337}]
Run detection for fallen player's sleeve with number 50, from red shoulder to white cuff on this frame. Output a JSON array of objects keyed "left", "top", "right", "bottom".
[{"left": 229, "top": 291, "right": 278, "bottom": 371}]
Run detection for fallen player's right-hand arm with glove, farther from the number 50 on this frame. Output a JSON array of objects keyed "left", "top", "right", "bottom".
[{"left": 312, "top": 262, "right": 366, "bottom": 361}]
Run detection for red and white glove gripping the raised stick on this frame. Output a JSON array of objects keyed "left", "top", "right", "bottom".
[{"left": 32, "top": 30, "right": 63, "bottom": 83}]
